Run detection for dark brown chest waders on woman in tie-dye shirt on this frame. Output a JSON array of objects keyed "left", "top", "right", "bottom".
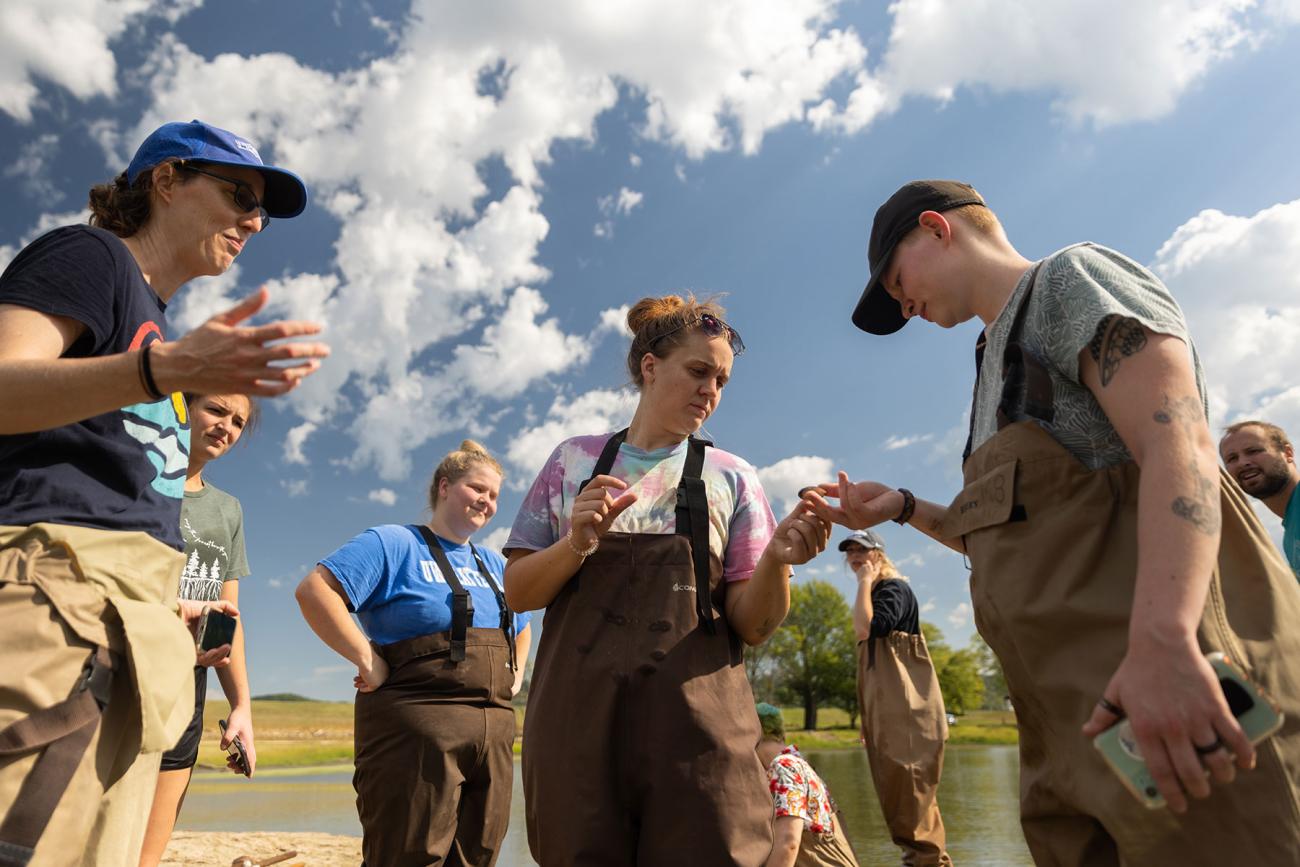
[{"left": 524, "top": 430, "right": 772, "bottom": 867}]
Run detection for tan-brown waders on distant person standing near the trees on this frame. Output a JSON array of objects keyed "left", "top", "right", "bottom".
[{"left": 858, "top": 632, "right": 953, "bottom": 867}]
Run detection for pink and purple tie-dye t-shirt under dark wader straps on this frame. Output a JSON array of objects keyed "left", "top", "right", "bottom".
[{"left": 504, "top": 434, "right": 776, "bottom": 581}]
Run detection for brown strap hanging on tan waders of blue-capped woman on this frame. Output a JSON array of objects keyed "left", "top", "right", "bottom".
[{"left": 0, "top": 647, "right": 113, "bottom": 864}]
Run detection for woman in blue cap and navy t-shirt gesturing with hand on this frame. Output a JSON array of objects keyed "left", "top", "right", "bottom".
[{"left": 0, "top": 121, "right": 329, "bottom": 864}]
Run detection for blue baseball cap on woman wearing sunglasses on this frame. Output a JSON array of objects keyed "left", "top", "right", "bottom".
[{"left": 126, "top": 121, "right": 307, "bottom": 220}]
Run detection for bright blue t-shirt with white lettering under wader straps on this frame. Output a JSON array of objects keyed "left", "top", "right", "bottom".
[{"left": 321, "top": 524, "right": 530, "bottom": 645}]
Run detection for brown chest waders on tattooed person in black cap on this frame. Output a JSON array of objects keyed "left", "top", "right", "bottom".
[{"left": 944, "top": 267, "right": 1300, "bottom": 867}]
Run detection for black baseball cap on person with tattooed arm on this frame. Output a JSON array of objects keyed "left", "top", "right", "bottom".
[{"left": 853, "top": 181, "right": 984, "bottom": 334}]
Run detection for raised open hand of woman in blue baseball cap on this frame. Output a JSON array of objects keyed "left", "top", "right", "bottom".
[{"left": 150, "top": 287, "right": 329, "bottom": 396}]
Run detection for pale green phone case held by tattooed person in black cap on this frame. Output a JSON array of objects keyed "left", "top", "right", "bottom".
[{"left": 1092, "top": 651, "right": 1282, "bottom": 810}]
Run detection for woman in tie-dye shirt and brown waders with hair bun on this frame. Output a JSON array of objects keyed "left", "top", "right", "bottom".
[{"left": 506, "top": 295, "right": 831, "bottom": 866}]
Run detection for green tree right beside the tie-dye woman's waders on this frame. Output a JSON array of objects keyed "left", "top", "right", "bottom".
[{"left": 770, "top": 581, "right": 857, "bottom": 729}]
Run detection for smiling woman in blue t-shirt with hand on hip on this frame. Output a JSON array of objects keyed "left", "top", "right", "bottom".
[{"left": 296, "top": 439, "right": 532, "bottom": 867}]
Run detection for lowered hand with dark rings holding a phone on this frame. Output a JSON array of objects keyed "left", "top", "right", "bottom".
[{"left": 1083, "top": 637, "right": 1255, "bottom": 812}]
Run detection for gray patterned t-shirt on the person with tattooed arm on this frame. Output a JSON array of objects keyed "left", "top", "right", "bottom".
[{"left": 971, "top": 243, "right": 1206, "bottom": 469}]
